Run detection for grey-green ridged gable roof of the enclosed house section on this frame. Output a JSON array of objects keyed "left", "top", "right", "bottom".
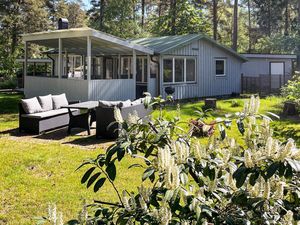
[{"left": 130, "top": 34, "right": 247, "bottom": 61}]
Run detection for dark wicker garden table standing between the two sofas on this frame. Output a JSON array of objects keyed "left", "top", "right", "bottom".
[{"left": 62, "top": 101, "right": 99, "bottom": 135}]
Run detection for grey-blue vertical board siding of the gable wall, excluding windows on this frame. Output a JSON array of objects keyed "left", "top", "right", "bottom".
[{"left": 160, "top": 40, "right": 242, "bottom": 99}]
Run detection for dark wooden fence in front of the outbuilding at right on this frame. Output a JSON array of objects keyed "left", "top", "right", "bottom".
[{"left": 241, "top": 74, "right": 291, "bottom": 95}]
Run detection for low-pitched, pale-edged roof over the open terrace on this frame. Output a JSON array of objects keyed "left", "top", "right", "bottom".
[{"left": 22, "top": 27, "right": 153, "bottom": 55}]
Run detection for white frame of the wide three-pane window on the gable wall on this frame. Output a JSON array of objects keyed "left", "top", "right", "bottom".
[{"left": 162, "top": 56, "right": 197, "bottom": 85}]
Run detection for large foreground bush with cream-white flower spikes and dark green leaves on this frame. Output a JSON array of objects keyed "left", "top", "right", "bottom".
[{"left": 72, "top": 96, "right": 300, "bottom": 225}]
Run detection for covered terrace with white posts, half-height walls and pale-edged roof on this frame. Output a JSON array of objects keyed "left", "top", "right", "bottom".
[{"left": 23, "top": 28, "right": 157, "bottom": 101}]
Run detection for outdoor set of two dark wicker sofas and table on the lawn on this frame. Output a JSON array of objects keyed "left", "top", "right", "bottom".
[{"left": 19, "top": 94, "right": 149, "bottom": 138}]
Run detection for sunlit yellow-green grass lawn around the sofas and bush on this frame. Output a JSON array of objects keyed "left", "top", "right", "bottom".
[{"left": 0, "top": 94, "right": 300, "bottom": 224}]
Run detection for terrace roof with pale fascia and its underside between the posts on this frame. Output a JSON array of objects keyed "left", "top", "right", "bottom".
[{"left": 23, "top": 27, "right": 154, "bottom": 55}]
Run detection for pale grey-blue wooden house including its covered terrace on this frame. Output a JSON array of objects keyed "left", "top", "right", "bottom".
[{"left": 23, "top": 28, "right": 247, "bottom": 100}]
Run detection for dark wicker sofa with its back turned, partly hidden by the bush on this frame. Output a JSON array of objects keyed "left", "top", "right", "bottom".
[{"left": 96, "top": 99, "right": 151, "bottom": 139}]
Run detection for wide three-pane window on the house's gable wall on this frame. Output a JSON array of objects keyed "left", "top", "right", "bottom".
[{"left": 163, "top": 57, "right": 196, "bottom": 83}]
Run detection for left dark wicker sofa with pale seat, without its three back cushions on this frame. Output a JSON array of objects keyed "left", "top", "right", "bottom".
[{"left": 19, "top": 93, "right": 79, "bottom": 134}]
